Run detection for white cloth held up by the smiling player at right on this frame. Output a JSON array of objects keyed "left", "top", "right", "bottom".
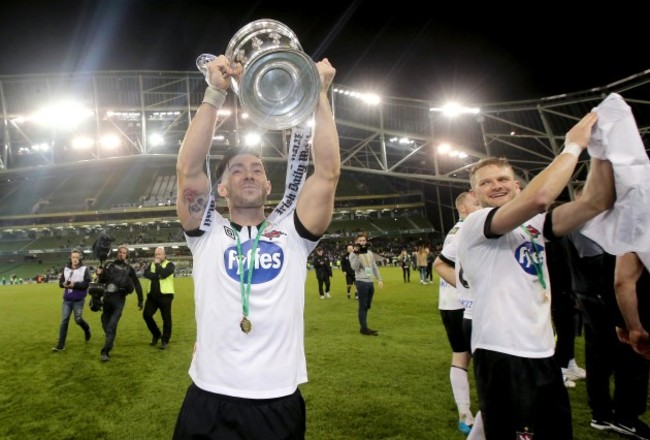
[{"left": 581, "top": 93, "right": 650, "bottom": 255}]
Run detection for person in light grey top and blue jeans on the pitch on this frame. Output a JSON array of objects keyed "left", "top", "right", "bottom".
[{"left": 350, "top": 232, "right": 384, "bottom": 336}]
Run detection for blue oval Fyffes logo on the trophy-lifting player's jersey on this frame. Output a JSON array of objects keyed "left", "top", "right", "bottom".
[{"left": 223, "top": 240, "right": 284, "bottom": 284}]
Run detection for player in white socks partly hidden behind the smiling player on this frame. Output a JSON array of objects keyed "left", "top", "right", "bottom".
[{"left": 433, "top": 191, "right": 481, "bottom": 434}]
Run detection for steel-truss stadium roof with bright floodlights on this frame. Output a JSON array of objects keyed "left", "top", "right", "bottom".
[{"left": 0, "top": 70, "right": 650, "bottom": 232}]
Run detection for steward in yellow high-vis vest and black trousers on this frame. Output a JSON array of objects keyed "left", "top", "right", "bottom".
[{"left": 142, "top": 247, "right": 175, "bottom": 350}]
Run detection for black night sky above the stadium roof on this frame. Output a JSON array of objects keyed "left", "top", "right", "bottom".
[{"left": 0, "top": 0, "right": 650, "bottom": 104}]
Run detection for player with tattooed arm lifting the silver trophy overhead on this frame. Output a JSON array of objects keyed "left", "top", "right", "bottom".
[{"left": 174, "top": 21, "right": 340, "bottom": 440}]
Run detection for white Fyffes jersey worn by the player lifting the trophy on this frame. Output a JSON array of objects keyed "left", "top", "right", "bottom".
[{"left": 186, "top": 211, "right": 318, "bottom": 399}]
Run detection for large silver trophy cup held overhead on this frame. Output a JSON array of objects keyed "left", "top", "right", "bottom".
[{"left": 196, "top": 19, "right": 321, "bottom": 130}]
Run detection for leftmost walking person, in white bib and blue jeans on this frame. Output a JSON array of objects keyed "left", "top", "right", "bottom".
[{"left": 52, "top": 249, "right": 90, "bottom": 351}]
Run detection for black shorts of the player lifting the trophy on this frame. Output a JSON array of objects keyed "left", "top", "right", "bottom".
[{"left": 173, "top": 384, "right": 306, "bottom": 440}]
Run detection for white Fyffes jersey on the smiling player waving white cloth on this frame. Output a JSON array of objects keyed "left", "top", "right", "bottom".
[{"left": 456, "top": 208, "right": 555, "bottom": 358}]
